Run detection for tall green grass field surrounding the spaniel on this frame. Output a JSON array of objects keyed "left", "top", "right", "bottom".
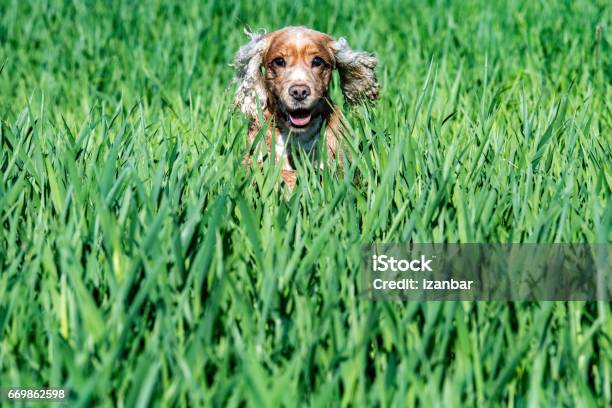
[{"left": 0, "top": 0, "right": 612, "bottom": 407}]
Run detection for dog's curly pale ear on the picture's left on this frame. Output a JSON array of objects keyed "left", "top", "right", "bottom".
[{"left": 233, "top": 28, "right": 268, "bottom": 118}]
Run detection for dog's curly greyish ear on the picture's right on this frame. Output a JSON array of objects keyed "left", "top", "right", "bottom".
[{"left": 331, "top": 38, "right": 378, "bottom": 104}]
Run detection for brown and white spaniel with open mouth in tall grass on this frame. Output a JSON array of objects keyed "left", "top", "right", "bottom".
[{"left": 233, "top": 27, "right": 379, "bottom": 189}]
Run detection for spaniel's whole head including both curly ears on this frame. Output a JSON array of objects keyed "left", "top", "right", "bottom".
[{"left": 234, "top": 27, "right": 378, "bottom": 133}]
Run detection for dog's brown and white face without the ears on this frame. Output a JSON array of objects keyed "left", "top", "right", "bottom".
[{"left": 263, "top": 27, "right": 335, "bottom": 133}]
